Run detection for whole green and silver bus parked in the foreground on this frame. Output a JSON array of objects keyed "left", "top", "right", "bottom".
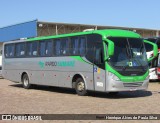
[{"left": 2, "top": 29, "right": 157, "bottom": 96}]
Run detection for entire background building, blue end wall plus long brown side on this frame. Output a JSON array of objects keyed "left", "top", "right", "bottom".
[{"left": 0, "top": 20, "right": 160, "bottom": 62}]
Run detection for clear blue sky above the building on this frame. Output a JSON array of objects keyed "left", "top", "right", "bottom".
[{"left": 0, "top": 0, "right": 160, "bottom": 30}]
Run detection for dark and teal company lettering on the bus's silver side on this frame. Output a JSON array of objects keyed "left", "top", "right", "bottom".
[{"left": 45, "top": 61, "right": 75, "bottom": 67}]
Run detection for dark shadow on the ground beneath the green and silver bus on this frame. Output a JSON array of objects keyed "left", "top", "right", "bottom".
[{"left": 9, "top": 84, "right": 152, "bottom": 99}]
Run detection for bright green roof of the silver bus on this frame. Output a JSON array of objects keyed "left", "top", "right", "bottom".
[{"left": 27, "top": 29, "right": 141, "bottom": 41}]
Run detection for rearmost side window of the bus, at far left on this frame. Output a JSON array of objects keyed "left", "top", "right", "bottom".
[{"left": 5, "top": 44, "right": 14, "bottom": 57}]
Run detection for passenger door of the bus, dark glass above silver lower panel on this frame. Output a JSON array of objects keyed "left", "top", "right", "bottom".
[{"left": 93, "top": 43, "right": 106, "bottom": 91}]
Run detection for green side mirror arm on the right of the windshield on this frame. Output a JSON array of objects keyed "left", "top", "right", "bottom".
[{"left": 144, "top": 40, "right": 158, "bottom": 62}]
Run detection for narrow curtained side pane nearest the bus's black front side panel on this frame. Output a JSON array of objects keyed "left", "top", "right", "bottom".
[{"left": 79, "top": 37, "right": 86, "bottom": 56}]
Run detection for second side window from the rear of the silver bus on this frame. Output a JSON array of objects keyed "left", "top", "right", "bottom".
[{"left": 16, "top": 43, "right": 25, "bottom": 57}]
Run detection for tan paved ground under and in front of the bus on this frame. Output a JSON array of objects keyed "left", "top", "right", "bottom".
[{"left": 0, "top": 79, "right": 160, "bottom": 123}]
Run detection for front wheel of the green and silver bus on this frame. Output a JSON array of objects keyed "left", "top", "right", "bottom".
[{"left": 75, "top": 78, "right": 87, "bottom": 96}]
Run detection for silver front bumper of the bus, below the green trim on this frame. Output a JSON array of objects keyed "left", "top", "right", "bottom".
[{"left": 106, "top": 79, "right": 149, "bottom": 92}]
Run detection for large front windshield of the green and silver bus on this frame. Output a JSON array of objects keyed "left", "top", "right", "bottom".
[{"left": 108, "top": 37, "right": 148, "bottom": 68}]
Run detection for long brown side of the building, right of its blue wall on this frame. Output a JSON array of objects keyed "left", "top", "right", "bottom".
[{"left": 37, "top": 21, "right": 160, "bottom": 37}]
